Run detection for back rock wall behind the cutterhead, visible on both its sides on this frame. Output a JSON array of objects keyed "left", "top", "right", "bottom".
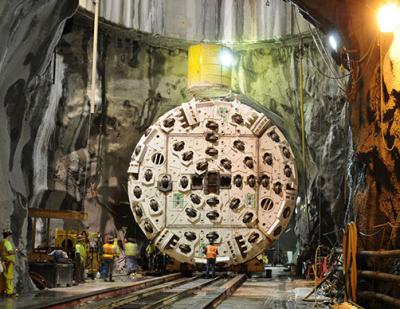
[{"left": 39, "top": 17, "right": 351, "bottom": 253}]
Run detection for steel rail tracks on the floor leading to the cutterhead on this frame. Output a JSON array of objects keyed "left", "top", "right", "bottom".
[{"left": 43, "top": 274, "right": 246, "bottom": 309}]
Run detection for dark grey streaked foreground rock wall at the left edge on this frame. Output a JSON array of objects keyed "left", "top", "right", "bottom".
[{"left": 0, "top": 0, "right": 78, "bottom": 291}]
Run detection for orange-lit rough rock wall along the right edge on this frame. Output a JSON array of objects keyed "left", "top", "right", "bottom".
[{"left": 295, "top": 0, "right": 400, "bottom": 308}]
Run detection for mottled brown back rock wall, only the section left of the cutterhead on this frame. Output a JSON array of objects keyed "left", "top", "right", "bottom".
[{"left": 35, "top": 17, "right": 189, "bottom": 241}]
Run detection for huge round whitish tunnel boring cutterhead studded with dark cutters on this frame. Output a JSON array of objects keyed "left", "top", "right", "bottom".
[{"left": 128, "top": 100, "right": 297, "bottom": 265}]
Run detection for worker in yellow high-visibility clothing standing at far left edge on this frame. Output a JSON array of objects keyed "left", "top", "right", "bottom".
[{"left": 0, "top": 229, "right": 16, "bottom": 297}]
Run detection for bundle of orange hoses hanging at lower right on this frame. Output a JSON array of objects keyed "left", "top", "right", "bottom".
[{"left": 343, "top": 222, "right": 357, "bottom": 302}]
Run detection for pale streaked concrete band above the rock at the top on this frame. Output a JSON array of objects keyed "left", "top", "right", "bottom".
[{"left": 79, "top": 0, "right": 309, "bottom": 43}]
